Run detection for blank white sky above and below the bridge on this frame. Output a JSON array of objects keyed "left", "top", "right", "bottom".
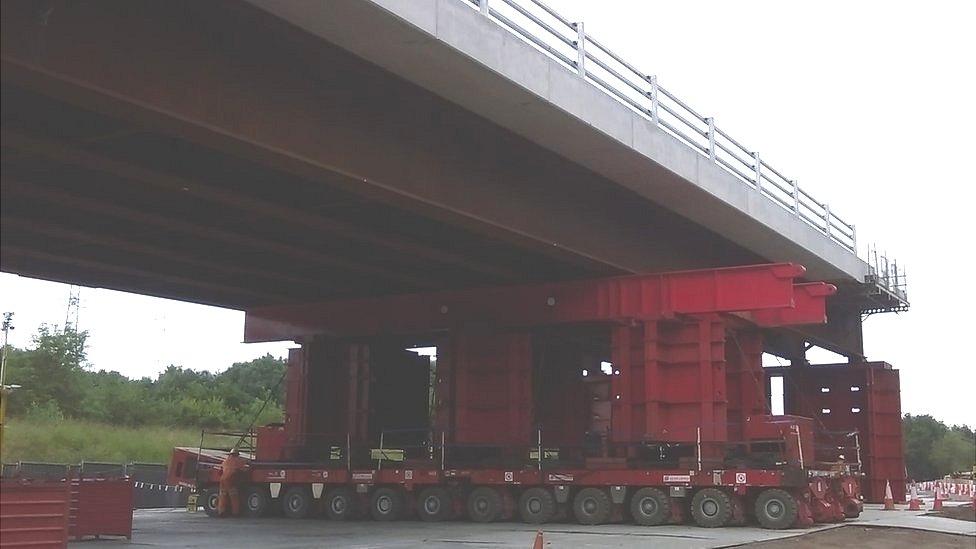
[{"left": 0, "top": 0, "right": 976, "bottom": 425}]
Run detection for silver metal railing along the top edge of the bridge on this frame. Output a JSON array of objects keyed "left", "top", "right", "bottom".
[{"left": 460, "top": 0, "right": 904, "bottom": 292}]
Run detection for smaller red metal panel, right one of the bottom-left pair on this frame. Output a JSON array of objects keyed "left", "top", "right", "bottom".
[{"left": 68, "top": 478, "right": 132, "bottom": 539}]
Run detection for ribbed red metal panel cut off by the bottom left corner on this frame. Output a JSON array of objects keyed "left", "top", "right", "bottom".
[{"left": 0, "top": 481, "right": 68, "bottom": 549}]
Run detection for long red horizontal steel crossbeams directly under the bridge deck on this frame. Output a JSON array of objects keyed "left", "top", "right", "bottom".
[{"left": 244, "top": 263, "right": 835, "bottom": 342}]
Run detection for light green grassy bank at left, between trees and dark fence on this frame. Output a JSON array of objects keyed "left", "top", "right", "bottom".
[{"left": 2, "top": 418, "right": 200, "bottom": 463}]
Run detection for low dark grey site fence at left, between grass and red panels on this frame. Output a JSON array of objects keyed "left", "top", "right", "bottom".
[{"left": 2, "top": 461, "right": 190, "bottom": 509}]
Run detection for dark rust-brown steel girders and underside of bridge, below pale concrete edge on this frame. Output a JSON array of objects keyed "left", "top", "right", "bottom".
[{"left": 0, "top": 1, "right": 860, "bottom": 354}]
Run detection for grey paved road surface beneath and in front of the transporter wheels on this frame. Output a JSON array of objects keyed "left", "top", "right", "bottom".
[{"left": 72, "top": 509, "right": 976, "bottom": 549}]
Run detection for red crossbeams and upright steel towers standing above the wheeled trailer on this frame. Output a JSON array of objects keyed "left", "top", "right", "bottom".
[{"left": 245, "top": 263, "right": 835, "bottom": 454}]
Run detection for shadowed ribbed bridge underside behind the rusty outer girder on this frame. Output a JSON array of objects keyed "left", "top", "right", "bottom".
[{"left": 0, "top": 86, "right": 598, "bottom": 308}]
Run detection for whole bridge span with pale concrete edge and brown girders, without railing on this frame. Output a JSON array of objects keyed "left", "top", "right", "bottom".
[{"left": 0, "top": 0, "right": 908, "bottom": 356}]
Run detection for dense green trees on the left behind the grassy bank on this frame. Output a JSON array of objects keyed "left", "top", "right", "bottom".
[{"left": 5, "top": 325, "right": 286, "bottom": 429}]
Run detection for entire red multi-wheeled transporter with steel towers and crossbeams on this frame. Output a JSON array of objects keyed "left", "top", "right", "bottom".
[{"left": 174, "top": 264, "right": 888, "bottom": 528}]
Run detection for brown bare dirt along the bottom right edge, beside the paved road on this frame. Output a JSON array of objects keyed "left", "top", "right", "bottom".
[{"left": 746, "top": 526, "right": 974, "bottom": 549}]
